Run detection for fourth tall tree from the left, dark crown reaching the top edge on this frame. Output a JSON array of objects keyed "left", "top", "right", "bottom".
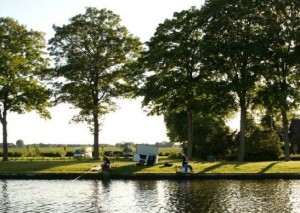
[{"left": 201, "top": 0, "right": 265, "bottom": 161}]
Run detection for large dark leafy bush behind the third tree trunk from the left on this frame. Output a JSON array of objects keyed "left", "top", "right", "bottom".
[{"left": 165, "top": 113, "right": 237, "bottom": 159}]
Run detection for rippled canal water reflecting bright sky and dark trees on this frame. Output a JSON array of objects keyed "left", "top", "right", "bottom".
[{"left": 0, "top": 180, "right": 300, "bottom": 213}]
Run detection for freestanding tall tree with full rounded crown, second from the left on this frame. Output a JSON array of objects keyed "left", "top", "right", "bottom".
[{"left": 49, "top": 8, "right": 140, "bottom": 159}]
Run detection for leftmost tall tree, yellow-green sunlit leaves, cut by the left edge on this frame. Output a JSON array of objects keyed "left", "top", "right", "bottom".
[{"left": 0, "top": 18, "right": 50, "bottom": 161}]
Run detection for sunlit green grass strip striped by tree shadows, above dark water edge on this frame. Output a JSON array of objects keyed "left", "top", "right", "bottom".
[{"left": 0, "top": 158, "right": 300, "bottom": 174}]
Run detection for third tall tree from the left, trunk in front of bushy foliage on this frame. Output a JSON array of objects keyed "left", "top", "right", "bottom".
[{"left": 140, "top": 7, "right": 206, "bottom": 158}]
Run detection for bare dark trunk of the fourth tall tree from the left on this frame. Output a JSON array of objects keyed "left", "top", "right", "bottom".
[{"left": 237, "top": 104, "right": 247, "bottom": 161}]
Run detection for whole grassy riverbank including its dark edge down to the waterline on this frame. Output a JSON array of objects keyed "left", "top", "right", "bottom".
[{"left": 0, "top": 158, "right": 300, "bottom": 180}]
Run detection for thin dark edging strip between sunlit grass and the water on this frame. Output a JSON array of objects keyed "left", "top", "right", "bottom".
[{"left": 0, "top": 172, "right": 300, "bottom": 180}]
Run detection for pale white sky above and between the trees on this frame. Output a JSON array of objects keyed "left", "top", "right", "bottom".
[{"left": 0, "top": 0, "right": 239, "bottom": 144}]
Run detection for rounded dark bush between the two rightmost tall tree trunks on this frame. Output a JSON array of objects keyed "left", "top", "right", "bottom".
[{"left": 245, "top": 127, "right": 282, "bottom": 161}]
